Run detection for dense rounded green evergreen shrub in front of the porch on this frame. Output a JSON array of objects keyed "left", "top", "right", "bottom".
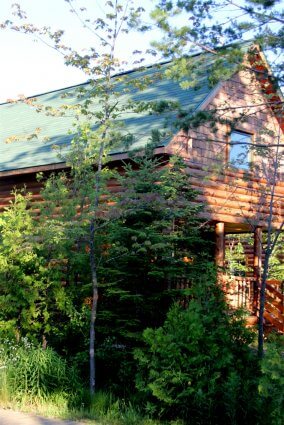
[{"left": 136, "top": 269, "right": 258, "bottom": 424}]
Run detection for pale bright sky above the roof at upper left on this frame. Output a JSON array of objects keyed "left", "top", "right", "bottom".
[{"left": 0, "top": 0, "right": 158, "bottom": 103}]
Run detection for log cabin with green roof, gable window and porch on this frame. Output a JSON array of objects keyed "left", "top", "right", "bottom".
[{"left": 0, "top": 46, "right": 284, "bottom": 332}]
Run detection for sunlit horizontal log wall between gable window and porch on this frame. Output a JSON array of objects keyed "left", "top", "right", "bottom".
[{"left": 185, "top": 162, "right": 284, "bottom": 225}]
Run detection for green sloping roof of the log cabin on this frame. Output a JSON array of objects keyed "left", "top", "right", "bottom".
[{"left": 0, "top": 58, "right": 215, "bottom": 171}]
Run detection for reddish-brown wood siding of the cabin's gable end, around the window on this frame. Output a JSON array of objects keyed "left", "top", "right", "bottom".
[{"left": 166, "top": 71, "right": 284, "bottom": 231}]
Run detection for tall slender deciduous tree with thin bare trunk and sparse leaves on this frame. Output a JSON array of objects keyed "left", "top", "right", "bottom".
[{"left": 1, "top": 0, "right": 158, "bottom": 394}]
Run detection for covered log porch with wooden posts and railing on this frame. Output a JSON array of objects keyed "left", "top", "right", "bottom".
[{"left": 215, "top": 222, "right": 284, "bottom": 333}]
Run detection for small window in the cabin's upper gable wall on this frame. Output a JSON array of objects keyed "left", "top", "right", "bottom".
[{"left": 229, "top": 131, "right": 252, "bottom": 170}]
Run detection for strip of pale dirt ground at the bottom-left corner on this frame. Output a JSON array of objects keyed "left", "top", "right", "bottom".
[{"left": 0, "top": 409, "right": 89, "bottom": 425}]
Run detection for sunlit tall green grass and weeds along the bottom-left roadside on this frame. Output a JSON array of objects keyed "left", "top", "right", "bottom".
[{"left": 0, "top": 339, "right": 186, "bottom": 425}]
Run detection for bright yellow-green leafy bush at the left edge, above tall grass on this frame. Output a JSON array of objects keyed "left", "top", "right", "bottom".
[{"left": 0, "top": 192, "right": 70, "bottom": 339}]
